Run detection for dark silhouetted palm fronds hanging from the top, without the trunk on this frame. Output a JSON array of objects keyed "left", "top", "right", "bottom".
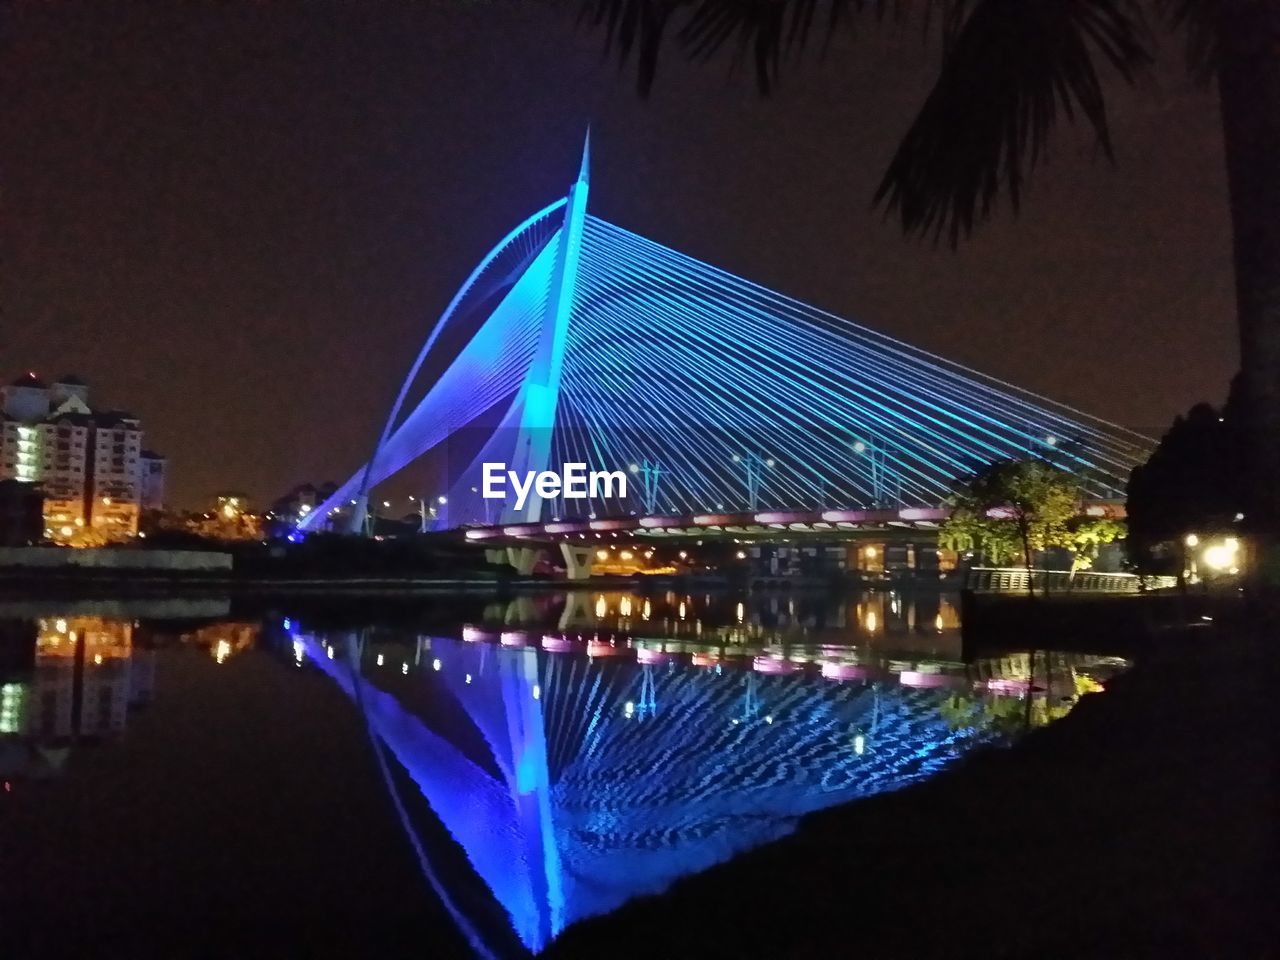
[{"left": 581, "top": 0, "right": 1221, "bottom": 244}]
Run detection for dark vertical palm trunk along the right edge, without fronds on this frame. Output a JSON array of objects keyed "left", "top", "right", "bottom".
[{"left": 1219, "top": 0, "right": 1280, "bottom": 585}]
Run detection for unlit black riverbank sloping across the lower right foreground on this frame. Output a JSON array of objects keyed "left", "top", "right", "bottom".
[{"left": 547, "top": 622, "right": 1277, "bottom": 960}]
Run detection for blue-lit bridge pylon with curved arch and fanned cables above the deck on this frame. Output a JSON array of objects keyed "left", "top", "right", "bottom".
[{"left": 301, "top": 135, "right": 1151, "bottom": 542}]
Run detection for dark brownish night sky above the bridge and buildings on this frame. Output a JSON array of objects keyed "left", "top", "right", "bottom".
[{"left": 0, "top": 0, "right": 1236, "bottom": 504}]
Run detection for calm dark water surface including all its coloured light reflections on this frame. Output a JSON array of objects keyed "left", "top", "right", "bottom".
[{"left": 0, "top": 591, "right": 1124, "bottom": 956}]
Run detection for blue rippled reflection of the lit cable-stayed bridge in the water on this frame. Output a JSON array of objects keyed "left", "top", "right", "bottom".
[{"left": 293, "top": 630, "right": 1114, "bottom": 951}]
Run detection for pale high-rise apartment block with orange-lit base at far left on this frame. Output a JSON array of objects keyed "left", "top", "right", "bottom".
[{"left": 0, "top": 374, "right": 165, "bottom": 544}]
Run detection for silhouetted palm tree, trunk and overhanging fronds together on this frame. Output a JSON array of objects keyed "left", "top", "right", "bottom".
[{"left": 585, "top": 0, "right": 1280, "bottom": 570}]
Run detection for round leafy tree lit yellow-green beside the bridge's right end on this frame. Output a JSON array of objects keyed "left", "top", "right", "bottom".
[{"left": 938, "top": 460, "right": 1080, "bottom": 596}]
